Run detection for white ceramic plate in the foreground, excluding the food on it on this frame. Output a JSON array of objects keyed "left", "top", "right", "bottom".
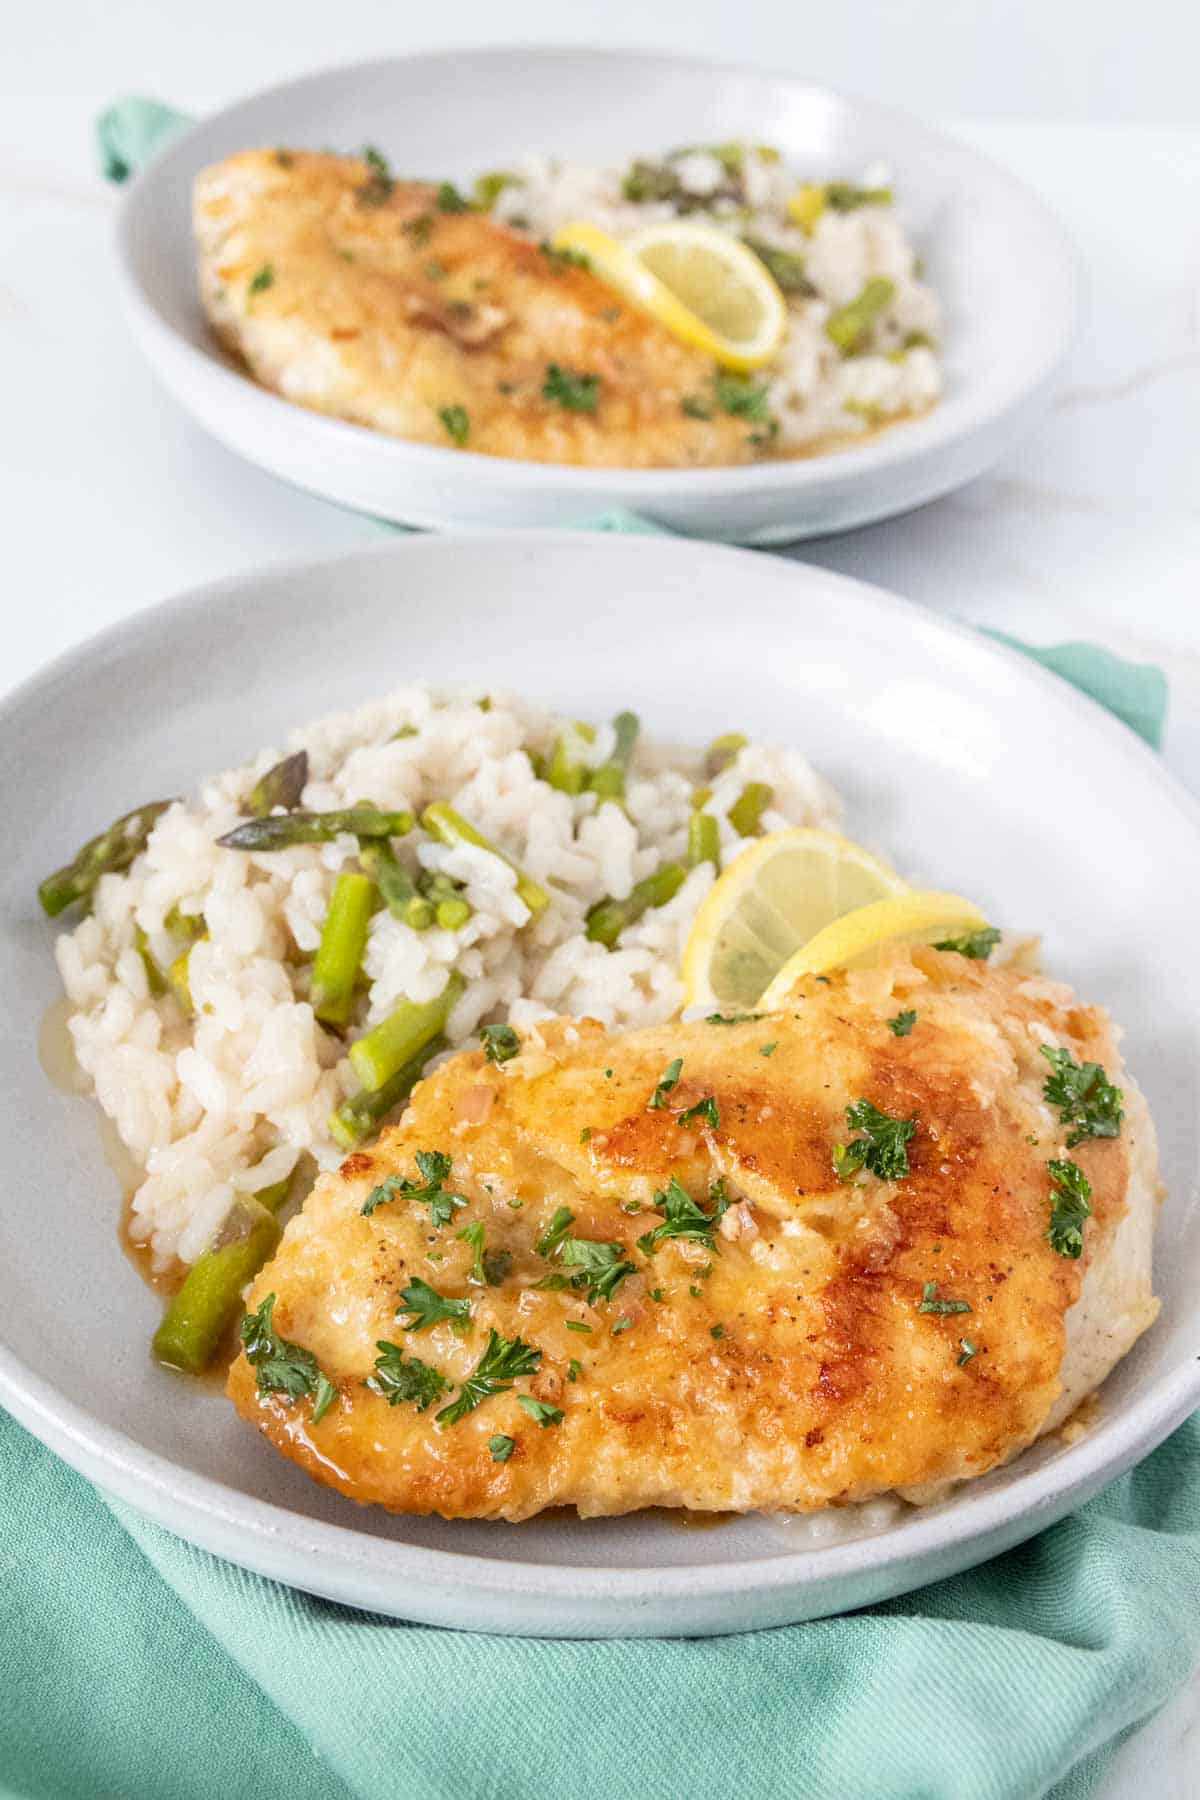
[{"left": 0, "top": 533, "right": 1200, "bottom": 1636}]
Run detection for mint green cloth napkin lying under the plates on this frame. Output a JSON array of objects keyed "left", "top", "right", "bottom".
[{"left": 0, "top": 103, "right": 1200, "bottom": 1800}]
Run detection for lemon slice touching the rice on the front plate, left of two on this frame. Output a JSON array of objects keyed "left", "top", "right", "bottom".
[{"left": 682, "top": 826, "right": 907, "bottom": 1012}]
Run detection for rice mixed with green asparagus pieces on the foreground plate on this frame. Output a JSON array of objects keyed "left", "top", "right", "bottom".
[{"left": 41, "top": 686, "right": 838, "bottom": 1273}]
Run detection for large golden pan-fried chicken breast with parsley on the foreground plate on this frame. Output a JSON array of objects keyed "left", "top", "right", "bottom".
[{"left": 228, "top": 949, "right": 1157, "bottom": 1519}]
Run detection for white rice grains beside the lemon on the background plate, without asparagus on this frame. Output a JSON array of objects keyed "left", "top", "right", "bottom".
[{"left": 493, "top": 148, "right": 943, "bottom": 455}]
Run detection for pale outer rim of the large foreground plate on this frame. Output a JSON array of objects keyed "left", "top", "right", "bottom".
[{"left": 0, "top": 527, "right": 1200, "bottom": 1629}]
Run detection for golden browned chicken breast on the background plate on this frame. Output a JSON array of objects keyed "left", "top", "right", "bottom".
[{"left": 194, "top": 149, "right": 761, "bottom": 468}]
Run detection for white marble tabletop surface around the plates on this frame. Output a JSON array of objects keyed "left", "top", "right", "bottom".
[{"left": 0, "top": 66, "right": 1200, "bottom": 1800}]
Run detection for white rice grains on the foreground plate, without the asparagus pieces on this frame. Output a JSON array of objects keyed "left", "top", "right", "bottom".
[{"left": 58, "top": 686, "right": 840, "bottom": 1269}]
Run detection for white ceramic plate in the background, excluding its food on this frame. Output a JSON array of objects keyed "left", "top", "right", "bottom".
[{"left": 121, "top": 49, "right": 1076, "bottom": 544}]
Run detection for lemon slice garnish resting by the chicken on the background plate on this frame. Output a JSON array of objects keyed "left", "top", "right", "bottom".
[{"left": 554, "top": 220, "right": 788, "bottom": 373}]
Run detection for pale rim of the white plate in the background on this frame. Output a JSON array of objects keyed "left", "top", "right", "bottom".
[{"left": 117, "top": 41, "right": 1083, "bottom": 506}]
